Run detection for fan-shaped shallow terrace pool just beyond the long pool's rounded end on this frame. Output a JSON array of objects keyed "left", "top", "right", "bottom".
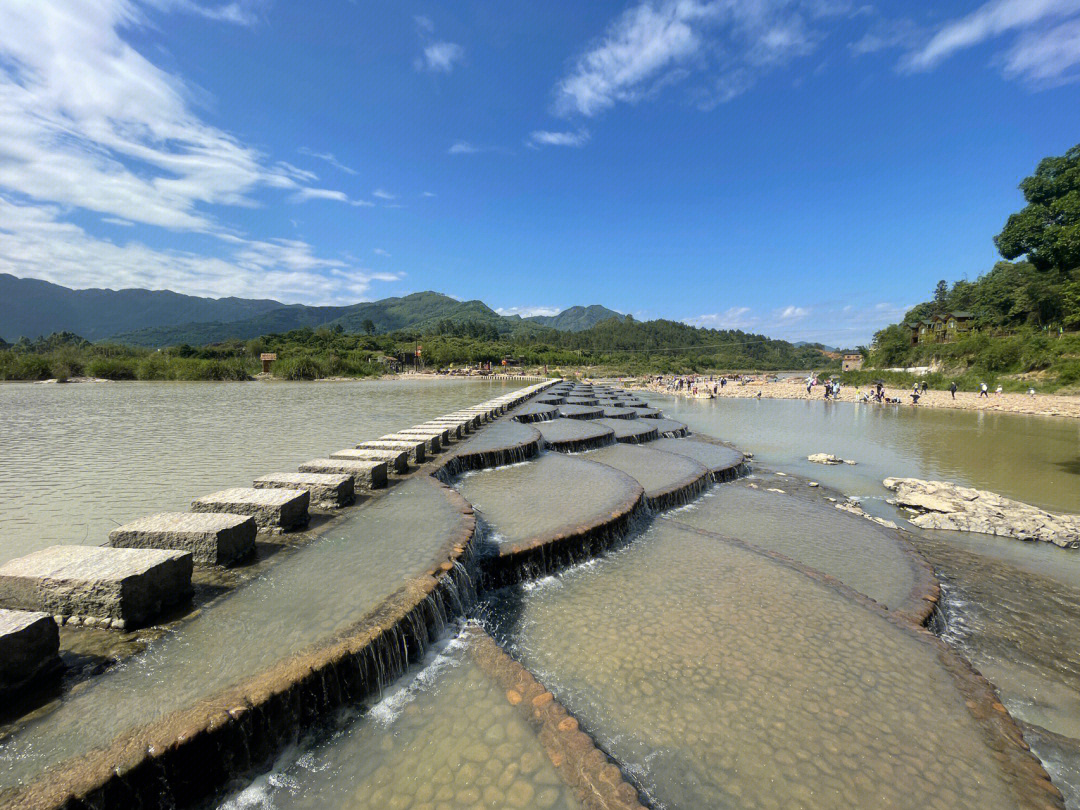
[{"left": 457, "top": 453, "right": 637, "bottom": 544}]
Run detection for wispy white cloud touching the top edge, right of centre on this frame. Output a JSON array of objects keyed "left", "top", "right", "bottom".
[{"left": 554, "top": 0, "right": 829, "bottom": 116}]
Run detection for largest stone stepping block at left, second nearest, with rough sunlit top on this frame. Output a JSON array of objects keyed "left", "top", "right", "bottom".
[{"left": 0, "top": 545, "right": 192, "bottom": 626}]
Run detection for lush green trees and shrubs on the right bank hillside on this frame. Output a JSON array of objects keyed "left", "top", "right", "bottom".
[{"left": 869, "top": 145, "right": 1080, "bottom": 384}]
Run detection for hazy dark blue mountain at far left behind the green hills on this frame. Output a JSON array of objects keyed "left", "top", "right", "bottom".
[{"left": 0, "top": 273, "right": 284, "bottom": 342}]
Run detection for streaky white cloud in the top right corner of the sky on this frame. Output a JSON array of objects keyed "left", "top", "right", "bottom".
[{"left": 901, "top": 0, "right": 1080, "bottom": 81}]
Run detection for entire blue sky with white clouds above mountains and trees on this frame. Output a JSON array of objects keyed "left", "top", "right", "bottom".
[{"left": 0, "top": 0, "right": 1080, "bottom": 345}]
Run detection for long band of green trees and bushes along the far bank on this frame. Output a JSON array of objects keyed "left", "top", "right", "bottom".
[{"left": 0, "top": 319, "right": 837, "bottom": 380}]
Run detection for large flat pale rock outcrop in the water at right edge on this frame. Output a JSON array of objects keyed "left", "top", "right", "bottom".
[{"left": 883, "top": 478, "right": 1080, "bottom": 549}]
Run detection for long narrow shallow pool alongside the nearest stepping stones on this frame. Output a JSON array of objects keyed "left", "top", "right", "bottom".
[{"left": 0, "top": 478, "right": 462, "bottom": 786}]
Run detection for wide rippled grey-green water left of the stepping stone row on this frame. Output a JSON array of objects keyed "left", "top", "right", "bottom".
[{"left": 0, "top": 379, "right": 526, "bottom": 562}]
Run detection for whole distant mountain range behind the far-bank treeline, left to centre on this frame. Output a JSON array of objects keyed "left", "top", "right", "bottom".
[{"left": 0, "top": 273, "right": 624, "bottom": 348}]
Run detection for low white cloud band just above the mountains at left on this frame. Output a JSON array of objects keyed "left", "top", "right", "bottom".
[{"left": 0, "top": 197, "right": 401, "bottom": 303}]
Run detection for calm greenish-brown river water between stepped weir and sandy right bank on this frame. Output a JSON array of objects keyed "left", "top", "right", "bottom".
[{"left": 649, "top": 394, "right": 1080, "bottom": 512}]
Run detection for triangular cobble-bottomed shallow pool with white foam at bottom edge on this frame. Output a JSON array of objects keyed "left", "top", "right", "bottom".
[{"left": 221, "top": 636, "right": 581, "bottom": 810}]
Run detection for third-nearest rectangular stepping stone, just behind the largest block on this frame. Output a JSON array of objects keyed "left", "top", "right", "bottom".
[{"left": 109, "top": 512, "right": 258, "bottom": 565}]
